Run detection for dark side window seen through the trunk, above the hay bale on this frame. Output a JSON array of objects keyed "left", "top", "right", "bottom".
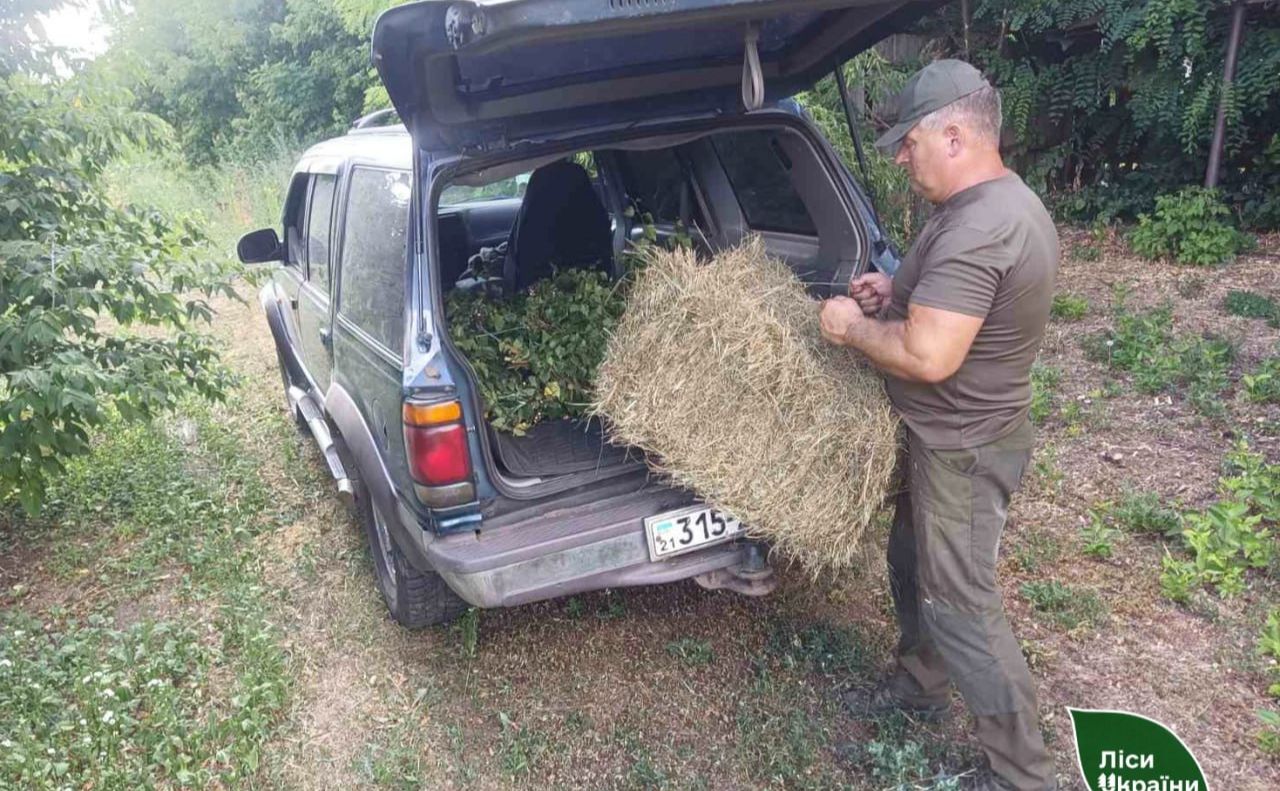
[{"left": 712, "top": 129, "right": 818, "bottom": 236}]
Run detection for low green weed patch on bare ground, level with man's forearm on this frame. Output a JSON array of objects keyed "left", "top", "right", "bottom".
[{"left": 1084, "top": 303, "right": 1235, "bottom": 417}]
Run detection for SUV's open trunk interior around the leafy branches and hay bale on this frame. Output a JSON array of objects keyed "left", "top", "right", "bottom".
[{"left": 436, "top": 113, "right": 867, "bottom": 491}]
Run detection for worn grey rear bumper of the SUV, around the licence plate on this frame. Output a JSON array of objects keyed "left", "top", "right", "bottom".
[{"left": 424, "top": 488, "right": 765, "bottom": 607}]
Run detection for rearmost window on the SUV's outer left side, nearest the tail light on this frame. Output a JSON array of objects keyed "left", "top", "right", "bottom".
[{"left": 338, "top": 168, "right": 410, "bottom": 356}]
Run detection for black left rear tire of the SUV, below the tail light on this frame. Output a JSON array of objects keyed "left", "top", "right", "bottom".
[{"left": 356, "top": 484, "right": 470, "bottom": 628}]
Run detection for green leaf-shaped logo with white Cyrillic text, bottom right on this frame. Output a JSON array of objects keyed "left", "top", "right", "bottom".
[{"left": 1066, "top": 707, "right": 1208, "bottom": 791}]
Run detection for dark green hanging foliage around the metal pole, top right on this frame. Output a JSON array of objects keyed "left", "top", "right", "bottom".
[{"left": 962, "top": 0, "right": 1280, "bottom": 227}]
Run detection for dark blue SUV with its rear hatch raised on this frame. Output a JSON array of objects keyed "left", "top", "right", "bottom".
[{"left": 238, "top": 0, "right": 937, "bottom": 626}]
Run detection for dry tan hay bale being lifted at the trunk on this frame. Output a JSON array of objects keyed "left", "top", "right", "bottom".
[{"left": 593, "top": 238, "right": 897, "bottom": 576}]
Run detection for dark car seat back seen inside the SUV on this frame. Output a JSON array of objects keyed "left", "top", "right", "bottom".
[{"left": 502, "top": 160, "right": 613, "bottom": 294}]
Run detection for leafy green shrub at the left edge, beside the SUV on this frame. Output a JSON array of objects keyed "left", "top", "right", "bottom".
[{"left": 0, "top": 16, "right": 236, "bottom": 512}]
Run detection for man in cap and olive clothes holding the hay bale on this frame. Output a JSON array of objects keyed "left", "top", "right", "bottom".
[{"left": 822, "top": 60, "right": 1059, "bottom": 791}]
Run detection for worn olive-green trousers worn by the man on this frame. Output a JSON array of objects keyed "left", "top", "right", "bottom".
[{"left": 888, "top": 422, "right": 1055, "bottom": 791}]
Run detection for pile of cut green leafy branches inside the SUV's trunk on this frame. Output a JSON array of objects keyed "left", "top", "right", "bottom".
[{"left": 445, "top": 269, "right": 625, "bottom": 436}]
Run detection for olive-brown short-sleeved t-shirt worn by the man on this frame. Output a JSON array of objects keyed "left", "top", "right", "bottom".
[{"left": 887, "top": 173, "right": 1059, "bottom": 449}]
